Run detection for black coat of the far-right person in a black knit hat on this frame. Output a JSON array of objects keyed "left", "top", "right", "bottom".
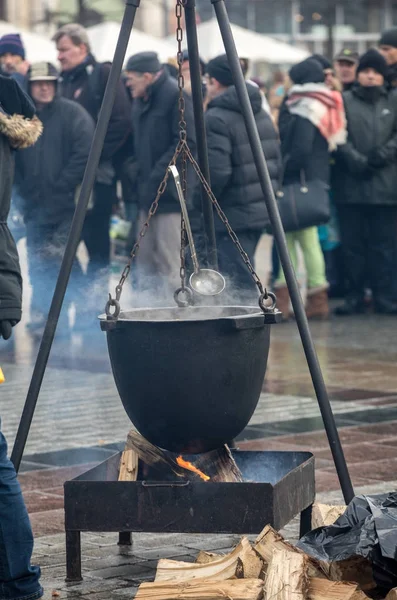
[{"left": 332, "top": 86, "right": 397, "bottom": 205}]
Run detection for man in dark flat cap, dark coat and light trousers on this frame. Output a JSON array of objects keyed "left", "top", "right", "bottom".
[{"left": 126, "top": 52, "right": 195, "bottom": 300}]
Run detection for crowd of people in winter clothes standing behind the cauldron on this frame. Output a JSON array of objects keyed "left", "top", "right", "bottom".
[{"left": 0, "top": 24, "right": 397, "bottom": 334}]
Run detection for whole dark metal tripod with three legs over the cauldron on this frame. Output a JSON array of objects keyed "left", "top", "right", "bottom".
[{"left": 11, "top": 0, "right": 354, "bottom": 503}]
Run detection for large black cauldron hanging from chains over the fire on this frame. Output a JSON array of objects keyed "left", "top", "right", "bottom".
[{"left": 101, "top": 306, "right": 274, "bottom": 453}]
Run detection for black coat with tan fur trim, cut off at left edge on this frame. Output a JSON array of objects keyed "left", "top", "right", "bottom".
[{"left": 0, "top": 76, "right": 41, "bottom": 321}]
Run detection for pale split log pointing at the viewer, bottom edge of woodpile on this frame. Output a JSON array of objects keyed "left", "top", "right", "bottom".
[{"left": 265, "top": 548, "right": 309, "bottom": 600}]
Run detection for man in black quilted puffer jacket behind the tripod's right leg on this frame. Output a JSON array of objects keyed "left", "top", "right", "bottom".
[{"left": 195, "top": 55, "right": 281, "bottom": 296}]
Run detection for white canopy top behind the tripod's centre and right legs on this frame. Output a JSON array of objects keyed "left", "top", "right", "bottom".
[{"left": 167, "top": 19, "right": 309, "bottom": 65}]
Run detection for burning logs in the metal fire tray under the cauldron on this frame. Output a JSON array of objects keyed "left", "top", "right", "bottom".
[{"left": 127, "top": 429, "right": 243, "bottom": 483}]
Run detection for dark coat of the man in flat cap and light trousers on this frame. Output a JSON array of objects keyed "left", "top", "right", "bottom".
[{"left": 132, "top": 70, "right": 195, "bottom": 213}]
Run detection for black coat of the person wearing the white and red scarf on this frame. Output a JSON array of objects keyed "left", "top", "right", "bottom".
[{"left": 279, "top": 102, "right": 330, "bottom": 184}]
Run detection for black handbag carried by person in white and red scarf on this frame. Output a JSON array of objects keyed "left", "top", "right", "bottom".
[{"left": 277, "top": 171, "right": 331, "bottom": 233}]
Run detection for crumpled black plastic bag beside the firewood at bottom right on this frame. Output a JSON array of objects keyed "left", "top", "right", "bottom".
[{"left": 298, "top": 492, "right": 397, "bottom": 592}]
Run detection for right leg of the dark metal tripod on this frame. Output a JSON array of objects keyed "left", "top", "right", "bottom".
[{"left": 211, "top": 0, "right": 354, "bottom": 503}]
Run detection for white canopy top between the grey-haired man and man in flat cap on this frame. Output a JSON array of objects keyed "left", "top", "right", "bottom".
[{"left": 87, "top": 21, "right": 176, "bottom": 62}]
